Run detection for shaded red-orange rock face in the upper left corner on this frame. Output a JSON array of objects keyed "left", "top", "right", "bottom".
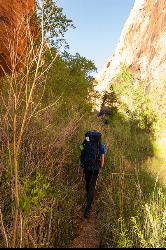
[{"left": 0, "top": 0, "right": 35, "bottom": 76}]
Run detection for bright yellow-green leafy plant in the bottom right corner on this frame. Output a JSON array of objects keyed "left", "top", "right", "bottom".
[{"left": 131, "top": 188, "right": 166, "bottom": 248}]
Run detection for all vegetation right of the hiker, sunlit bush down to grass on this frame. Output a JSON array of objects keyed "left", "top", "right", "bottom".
[{"left": 98, "top": 65, "right": 166, "bottom": 248}]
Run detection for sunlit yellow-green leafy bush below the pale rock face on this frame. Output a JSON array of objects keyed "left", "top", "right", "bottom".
[{"left": 104, "top": 63, "right": 165, "bottom": 131}]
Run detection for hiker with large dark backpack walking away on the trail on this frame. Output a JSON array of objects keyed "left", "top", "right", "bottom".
[{"left": 78, "top": 130, "right": 105, "bottom": 218}]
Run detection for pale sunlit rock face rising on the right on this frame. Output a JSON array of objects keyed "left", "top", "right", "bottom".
[{"left": 95, "top": 0, "right": 166, "bottom": 110}]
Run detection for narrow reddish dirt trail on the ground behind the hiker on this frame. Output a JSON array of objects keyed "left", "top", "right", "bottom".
[{"left": 72, "top": 204, "right": 100, "bottom": 248}]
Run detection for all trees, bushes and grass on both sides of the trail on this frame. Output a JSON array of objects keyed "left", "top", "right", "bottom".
[{"left": 0, "top": 0, "right": 166, "bottom": 248}]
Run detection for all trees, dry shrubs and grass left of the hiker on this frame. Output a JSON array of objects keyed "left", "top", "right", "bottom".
[{"left": 0, "top": 1, "right": 96, "bottom": 247}]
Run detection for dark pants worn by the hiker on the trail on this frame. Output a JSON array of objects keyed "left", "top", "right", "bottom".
[{"left": 84, "top": 170, "right": 99, "bottom": 210}]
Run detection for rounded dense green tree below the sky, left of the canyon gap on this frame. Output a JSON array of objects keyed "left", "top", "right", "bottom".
[{"left": 45, "top": 51, "right": 96, "bottom": 115}]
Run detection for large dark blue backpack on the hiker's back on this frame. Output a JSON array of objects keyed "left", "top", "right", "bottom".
[{"left": 80, "top": 131, "right": 101, "bottom": 171}]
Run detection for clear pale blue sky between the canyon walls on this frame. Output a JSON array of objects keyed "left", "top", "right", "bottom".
[{"left": 57, "top": 0, "right": 134, "bottom": 72}]
